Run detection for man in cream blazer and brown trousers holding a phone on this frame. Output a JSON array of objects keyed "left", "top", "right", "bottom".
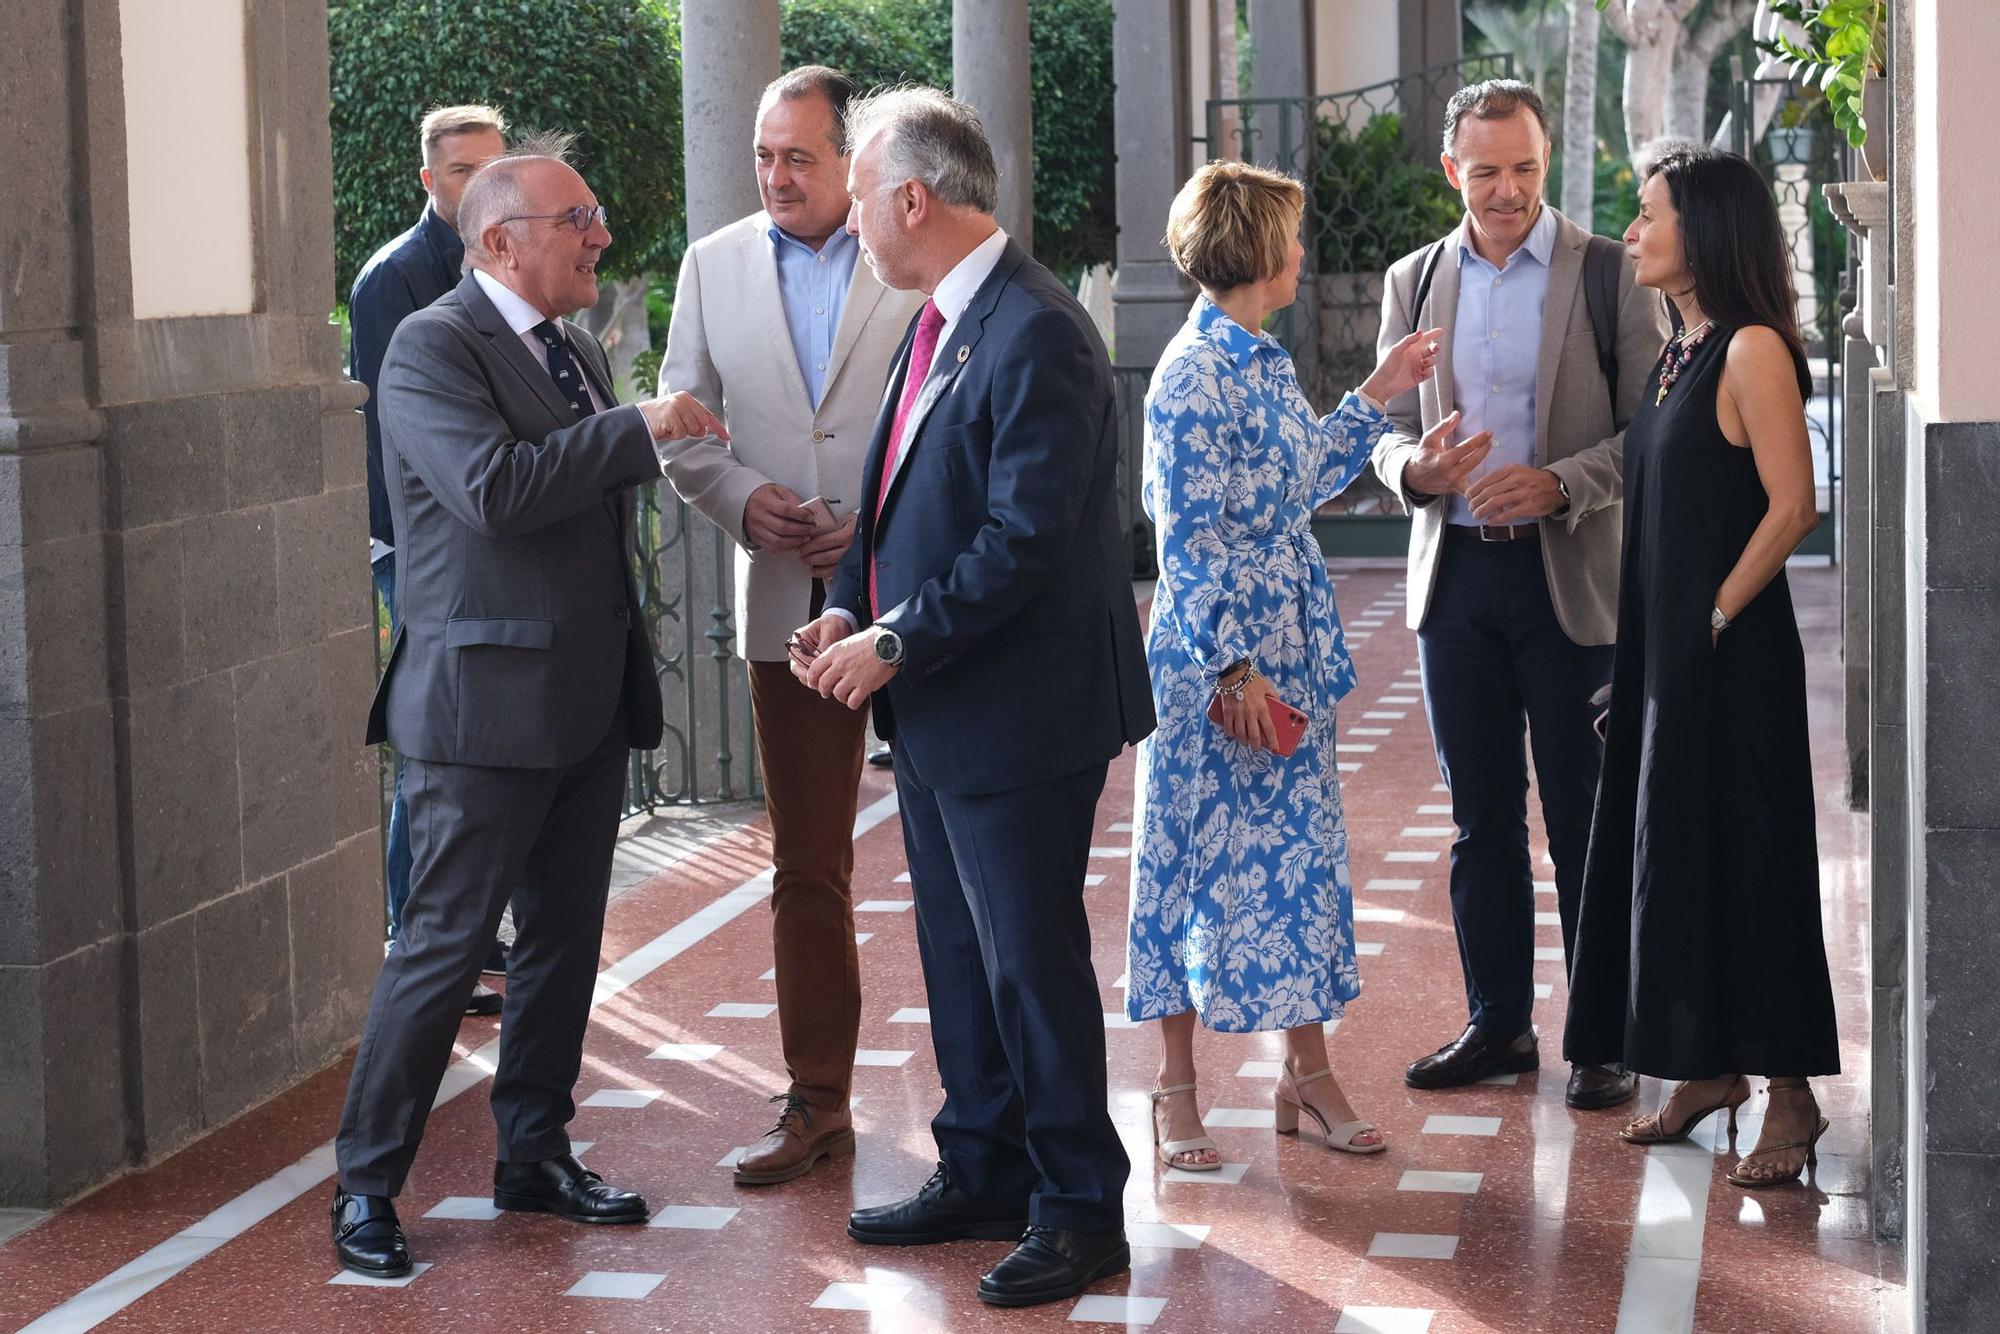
[{"left": 660, "top": 66, "right": 922, "bottom": 1186}]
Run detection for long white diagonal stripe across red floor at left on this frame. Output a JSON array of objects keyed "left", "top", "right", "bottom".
[{"left": 18, "top": 794, "right": 896, "bottom": 1334}]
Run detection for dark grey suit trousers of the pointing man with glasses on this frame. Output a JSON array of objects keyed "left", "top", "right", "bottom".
[{"left": 334, "top": 710, "right": 628, "bottom": 1196}]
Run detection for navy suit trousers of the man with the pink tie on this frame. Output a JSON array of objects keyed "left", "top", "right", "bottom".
[{"left": 896, "top": 746, "right": 1132, "bottom": 1232}]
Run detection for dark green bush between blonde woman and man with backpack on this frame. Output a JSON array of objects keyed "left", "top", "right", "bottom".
[{"left": 1312, "top": 112, "right": 1464, "bottom": 274}]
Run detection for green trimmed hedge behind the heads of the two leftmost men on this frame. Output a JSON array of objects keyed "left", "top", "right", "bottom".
[{"left": 326, "top": 0, "right": 686, "bottom": 292}]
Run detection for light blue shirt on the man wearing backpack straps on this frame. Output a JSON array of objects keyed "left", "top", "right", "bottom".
[{"left": 1446, "top": 204, "right": 1556, "bottom": 524}]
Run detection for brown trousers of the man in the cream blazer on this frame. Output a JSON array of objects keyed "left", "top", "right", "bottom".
[{"left": 750, "top": 662, "right": 868, "bottom": 1114}]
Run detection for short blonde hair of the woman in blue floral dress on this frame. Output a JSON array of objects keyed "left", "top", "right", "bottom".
[{"left": 1166, "top": 162, "right": 1306, "bottom": 292}]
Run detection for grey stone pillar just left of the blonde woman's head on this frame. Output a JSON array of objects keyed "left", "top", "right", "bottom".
[{"left": 1112, "top": 0, "right": 1194, "bottom": 370}]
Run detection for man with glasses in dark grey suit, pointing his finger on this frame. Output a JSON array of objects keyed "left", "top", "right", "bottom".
[{"left": 334, "top": 142, "right": 726, "bottom": 1276}]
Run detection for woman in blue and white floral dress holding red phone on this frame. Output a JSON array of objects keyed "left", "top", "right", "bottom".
[{"left": 1126, "top": 162, "right": 1438, "bottom": 1172}]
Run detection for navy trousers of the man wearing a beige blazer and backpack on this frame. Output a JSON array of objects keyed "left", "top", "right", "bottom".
[{"left": 1416, "top": 536, "right": 1612, "bottom": 1040}]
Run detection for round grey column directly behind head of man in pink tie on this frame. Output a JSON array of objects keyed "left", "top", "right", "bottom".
[{"left": 952, "top": 0, "right": 1034, "bottom": 254}]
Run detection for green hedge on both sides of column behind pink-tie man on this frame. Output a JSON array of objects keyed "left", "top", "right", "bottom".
[{"left": 782, "top": 0, "right": 1116, "bottom": 276}]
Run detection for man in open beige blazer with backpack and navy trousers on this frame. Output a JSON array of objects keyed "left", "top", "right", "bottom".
[{"left": 1374, "top": 80, "right": 1666, "bottom": 1108}]
